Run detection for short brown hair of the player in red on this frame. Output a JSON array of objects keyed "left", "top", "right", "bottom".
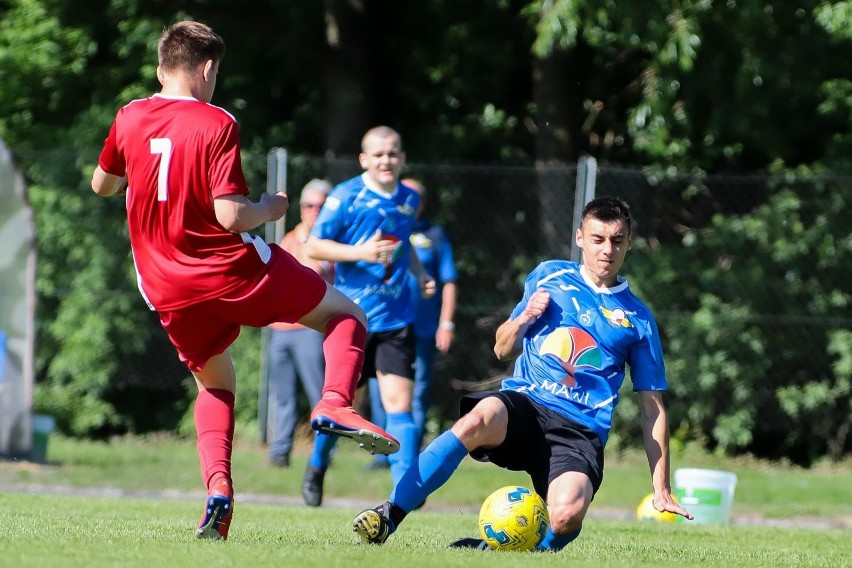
[{"left": 157, "top": 21, "right": 225, "bottom": 72}]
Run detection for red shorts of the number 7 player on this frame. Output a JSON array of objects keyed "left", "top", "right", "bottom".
[{"left": 159, "top": 244, "right": 326, "bottom": 371}]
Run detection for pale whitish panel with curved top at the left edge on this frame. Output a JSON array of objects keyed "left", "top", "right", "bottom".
[{"left": 0, "top": 141, "right": 35, "bottom": 455}]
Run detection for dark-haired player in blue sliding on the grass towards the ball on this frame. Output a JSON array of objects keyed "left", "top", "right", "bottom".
[{"left": 353, "top": 197, "right": 693, "bottom": 551}]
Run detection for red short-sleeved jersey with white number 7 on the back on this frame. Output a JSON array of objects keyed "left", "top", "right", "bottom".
[{"left": 98, "top": 94, "right": 270, "bottom": 311}]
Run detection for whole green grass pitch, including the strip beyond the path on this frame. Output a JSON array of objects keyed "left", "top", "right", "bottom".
[{"left": 0, "top": 433, "right": 852, "bottom": 568}]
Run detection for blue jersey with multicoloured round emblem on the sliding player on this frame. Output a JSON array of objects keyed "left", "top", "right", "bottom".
[{"left": 502, "top": 260, "right": 668, "bottom": 444}]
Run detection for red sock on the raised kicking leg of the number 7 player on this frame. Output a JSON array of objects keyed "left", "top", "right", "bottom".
[{"left": 322, "top": 314, "right": 367, "bottom": 406}]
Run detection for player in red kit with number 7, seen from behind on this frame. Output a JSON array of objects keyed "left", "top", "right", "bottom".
[{"left": 92, "top": 21, "right": 399, "bottom": 540}]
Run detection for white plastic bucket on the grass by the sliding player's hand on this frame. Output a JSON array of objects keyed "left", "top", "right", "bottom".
[{"left": 674, "top": 468, "right": 737, "bottom": 525}]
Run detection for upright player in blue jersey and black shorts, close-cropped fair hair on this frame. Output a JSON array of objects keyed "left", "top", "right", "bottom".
[{"left": 302, "top": 126, "right": 435, "bottom": 507}]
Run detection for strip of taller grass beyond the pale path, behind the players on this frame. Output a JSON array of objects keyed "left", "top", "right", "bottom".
[{"left": 0, "top": 432, "right": 852, "bottom": 519}]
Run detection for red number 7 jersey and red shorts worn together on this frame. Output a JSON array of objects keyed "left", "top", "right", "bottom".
[{"left": 98, "top": 94, "right": 326, "bottom": 371}]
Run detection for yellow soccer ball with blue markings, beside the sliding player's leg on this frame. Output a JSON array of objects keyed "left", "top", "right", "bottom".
[{"left": 479, "top": 485, "right": 550, "bottom": 550}]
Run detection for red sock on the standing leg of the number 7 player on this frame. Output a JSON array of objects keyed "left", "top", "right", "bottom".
[{"left": 195, "top": 389, "right": 234, "bottom": 490}]
